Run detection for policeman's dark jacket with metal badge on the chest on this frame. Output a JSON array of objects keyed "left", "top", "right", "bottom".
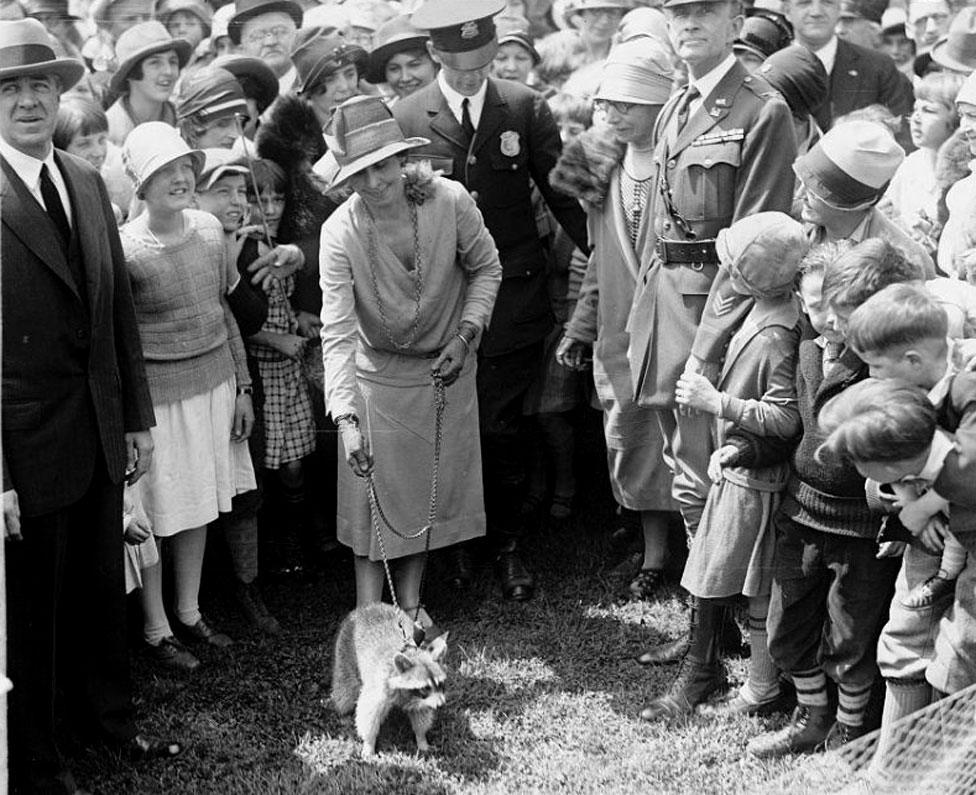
[{"left": 393, "top": 78, "right": 589, "bottom": 356}]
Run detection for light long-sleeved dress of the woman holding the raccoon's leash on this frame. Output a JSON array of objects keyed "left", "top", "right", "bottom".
[{"left": 320, "top": 177, "right": 501, "bottom": 560}]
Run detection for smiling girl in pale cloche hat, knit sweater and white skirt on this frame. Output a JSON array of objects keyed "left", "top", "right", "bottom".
[{"left": 121, "top": 122, "right": 255, "bottom": 670}]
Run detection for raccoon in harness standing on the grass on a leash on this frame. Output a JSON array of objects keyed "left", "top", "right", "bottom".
[{"left": 332, "top": 603, "right": 447, "bottom": 757}]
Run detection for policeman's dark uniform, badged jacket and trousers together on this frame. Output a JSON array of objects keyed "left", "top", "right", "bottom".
[{"left": 393, "top": 10, "right": 588, "bottom": 584}]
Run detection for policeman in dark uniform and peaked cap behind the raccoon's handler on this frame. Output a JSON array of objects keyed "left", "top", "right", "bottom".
[{"left": 393, "top": 0, "right": 588, "bottom": 600}]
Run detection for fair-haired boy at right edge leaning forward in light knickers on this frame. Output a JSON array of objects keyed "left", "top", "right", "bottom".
[{"left": 848, "top": 285, "right": 976, "bottom": 708}]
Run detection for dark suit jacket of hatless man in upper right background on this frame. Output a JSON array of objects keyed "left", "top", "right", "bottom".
[{"left": 816, "top": 39, "right": 915, "bottom": 151}]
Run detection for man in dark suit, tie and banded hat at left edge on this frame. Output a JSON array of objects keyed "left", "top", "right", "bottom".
[{"left": 0, "top": 20, "right": 180, "bottom": 792}]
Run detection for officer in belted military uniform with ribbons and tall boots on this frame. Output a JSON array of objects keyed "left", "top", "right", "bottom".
[{"left": 628, "top": 0, "right": 796, "bottom": 720}]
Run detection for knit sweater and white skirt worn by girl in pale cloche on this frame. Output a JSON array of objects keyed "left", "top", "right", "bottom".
[{"left": 120, "top": 210, "right": 256, "bottom": 536}]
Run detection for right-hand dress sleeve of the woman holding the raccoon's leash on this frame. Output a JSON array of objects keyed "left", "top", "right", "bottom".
[{"left": 454, "top": 190, "right": 502, "bottom": 333}]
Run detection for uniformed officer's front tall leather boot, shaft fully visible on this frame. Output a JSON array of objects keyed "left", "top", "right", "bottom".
[{"left": 640, "top": 599, "right": 727, "bottom": 721}]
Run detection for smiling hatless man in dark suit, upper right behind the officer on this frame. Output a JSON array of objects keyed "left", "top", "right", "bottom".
[{"left": 786, "top": 0, "right": 915, "bottom": 146}]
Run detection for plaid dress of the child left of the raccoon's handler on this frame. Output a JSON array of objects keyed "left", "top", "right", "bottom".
[{"left": 248, "top": 276, "right": 315, "bottom": 469}]
